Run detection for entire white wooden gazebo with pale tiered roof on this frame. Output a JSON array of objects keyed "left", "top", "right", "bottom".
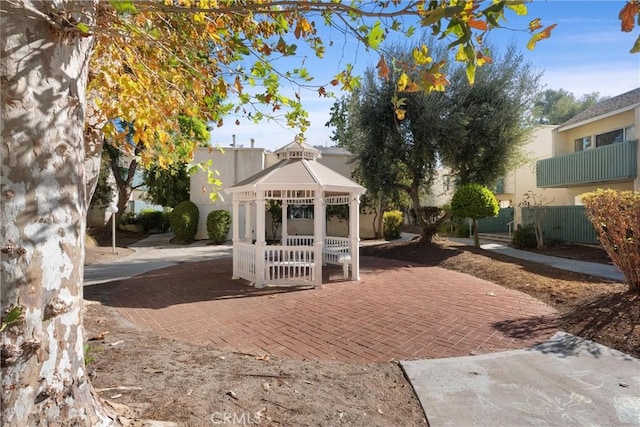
[{"left": 225, "top": 142, "right": 366, "bottom": 288}]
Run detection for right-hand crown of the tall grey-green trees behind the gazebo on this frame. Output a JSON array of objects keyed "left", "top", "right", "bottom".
[{"left": 438, "top": 45, "right": 541, "bottom": 186}]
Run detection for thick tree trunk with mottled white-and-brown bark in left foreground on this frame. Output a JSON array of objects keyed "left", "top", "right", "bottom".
[{"left": 0, "top": 0, "right": 112, "bottom": 426}]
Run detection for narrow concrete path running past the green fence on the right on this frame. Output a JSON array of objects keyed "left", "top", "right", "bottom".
[{"left": 449, "top": 237, "right": 624, "bottom": 282}]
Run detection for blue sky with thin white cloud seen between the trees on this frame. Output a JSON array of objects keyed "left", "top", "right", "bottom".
[{"left": 210, "top": 0, "right": 640, "bottom": 151}]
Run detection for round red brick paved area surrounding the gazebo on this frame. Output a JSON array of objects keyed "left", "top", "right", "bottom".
[{"left": 85, "top": 257, "right": 558, "bottom": 362}]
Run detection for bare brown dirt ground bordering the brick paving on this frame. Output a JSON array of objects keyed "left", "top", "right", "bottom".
[{"left": 85, "top": 232, "right": 640, "bottom": 426}]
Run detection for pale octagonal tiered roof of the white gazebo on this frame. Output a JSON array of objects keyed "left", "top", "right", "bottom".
[{"left": 225, "top": 142, "right": 366, "bottom": 194}]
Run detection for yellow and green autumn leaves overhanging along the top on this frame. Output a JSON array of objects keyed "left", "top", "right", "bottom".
[{"left": 89, "top": 0, "right": 552, "bottom": 164}]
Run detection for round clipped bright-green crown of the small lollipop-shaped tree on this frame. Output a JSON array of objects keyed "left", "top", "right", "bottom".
[{"left": 451, "top": 183, "right": 500, "bottom": 220}]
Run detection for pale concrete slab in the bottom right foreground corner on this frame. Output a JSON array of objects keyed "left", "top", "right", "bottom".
[{"left": 401, "top": 332, "right": 640, "bottom": 427}]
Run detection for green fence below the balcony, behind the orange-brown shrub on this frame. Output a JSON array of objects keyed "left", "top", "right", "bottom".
[{"left": 522, "top": 206, "right": 600, "bottom": 245}]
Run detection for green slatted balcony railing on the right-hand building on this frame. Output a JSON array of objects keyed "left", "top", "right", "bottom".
[{"left": 536, "top": 140, "right": 638, "bottom": 187}]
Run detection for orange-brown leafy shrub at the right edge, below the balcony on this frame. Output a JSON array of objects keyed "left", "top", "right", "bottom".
[{"left": 582, "top": 190, "right": 640, "bottom": 294}]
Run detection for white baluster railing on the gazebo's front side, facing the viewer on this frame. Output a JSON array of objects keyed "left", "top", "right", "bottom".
[{"left": 264, "top": 245, "right": 316, "bottom": 284}]
